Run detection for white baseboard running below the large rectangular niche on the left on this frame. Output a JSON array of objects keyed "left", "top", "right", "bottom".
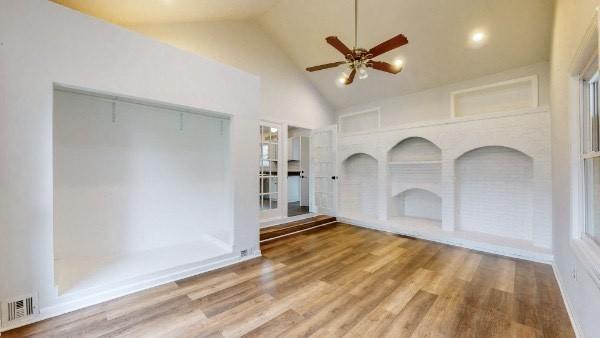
[{"left": 0, "top": 250, "right": 261, "bottom": 334}]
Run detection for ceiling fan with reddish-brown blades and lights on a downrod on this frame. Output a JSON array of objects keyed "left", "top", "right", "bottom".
[{"left": 306, "top": 0, "right": 408, "bottom": 85}]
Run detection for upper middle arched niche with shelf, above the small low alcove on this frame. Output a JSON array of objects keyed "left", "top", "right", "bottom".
[{"left": 388, "top": 137, "right": 442, "bottom": 163}]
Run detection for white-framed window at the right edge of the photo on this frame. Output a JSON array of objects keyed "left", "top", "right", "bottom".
[{"left": 580, "top": 57, "right": 600, "bottom": 245}]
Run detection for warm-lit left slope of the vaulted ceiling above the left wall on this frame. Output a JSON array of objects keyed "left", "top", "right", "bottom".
[{"left": 52, "top": 0, "right": 279, "bottom": 25}]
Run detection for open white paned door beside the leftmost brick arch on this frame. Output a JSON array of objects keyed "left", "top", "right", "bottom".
[{"left": 310, "top": 125, "right": 338, "bottom": 216}]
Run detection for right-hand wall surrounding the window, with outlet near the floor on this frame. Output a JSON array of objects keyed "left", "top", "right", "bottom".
[{"left": 550, "top": 0, "right": 600, "bottom": 337}]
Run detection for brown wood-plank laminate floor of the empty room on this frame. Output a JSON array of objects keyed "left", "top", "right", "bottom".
[{"left": 2, "top": 223, "right": 574, "bottom": 337}]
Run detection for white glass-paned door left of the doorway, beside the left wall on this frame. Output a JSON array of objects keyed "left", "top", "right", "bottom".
[{"left": 258, "top": 122, "right": 283, "bottom": 220}]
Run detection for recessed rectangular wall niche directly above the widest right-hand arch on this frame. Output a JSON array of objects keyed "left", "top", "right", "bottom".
[{"left": 450, "top": 75, "right": 538, "bottom": 117}]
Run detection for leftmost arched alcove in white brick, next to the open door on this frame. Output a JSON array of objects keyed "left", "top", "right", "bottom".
[{"left": 339, "top": 153, "right": 378, "bottom": 217}]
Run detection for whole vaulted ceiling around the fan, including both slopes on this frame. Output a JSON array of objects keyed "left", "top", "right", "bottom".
[{"left": 50, "top": 0, "right": 554, "bottom": 108}]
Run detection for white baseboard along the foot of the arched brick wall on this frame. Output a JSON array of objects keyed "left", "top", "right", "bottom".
[{"left": 337, "top": 216, "right": 554, "bottom": 264}]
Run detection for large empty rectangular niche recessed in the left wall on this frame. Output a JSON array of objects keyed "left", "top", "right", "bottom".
[{"left": 53, "top": 88, "right": 233, "bottom": 294}]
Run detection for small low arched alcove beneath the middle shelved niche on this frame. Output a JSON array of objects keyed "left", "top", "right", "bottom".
[{"left": 389, "top": 188, "right": 442, "bottom": 221}]
